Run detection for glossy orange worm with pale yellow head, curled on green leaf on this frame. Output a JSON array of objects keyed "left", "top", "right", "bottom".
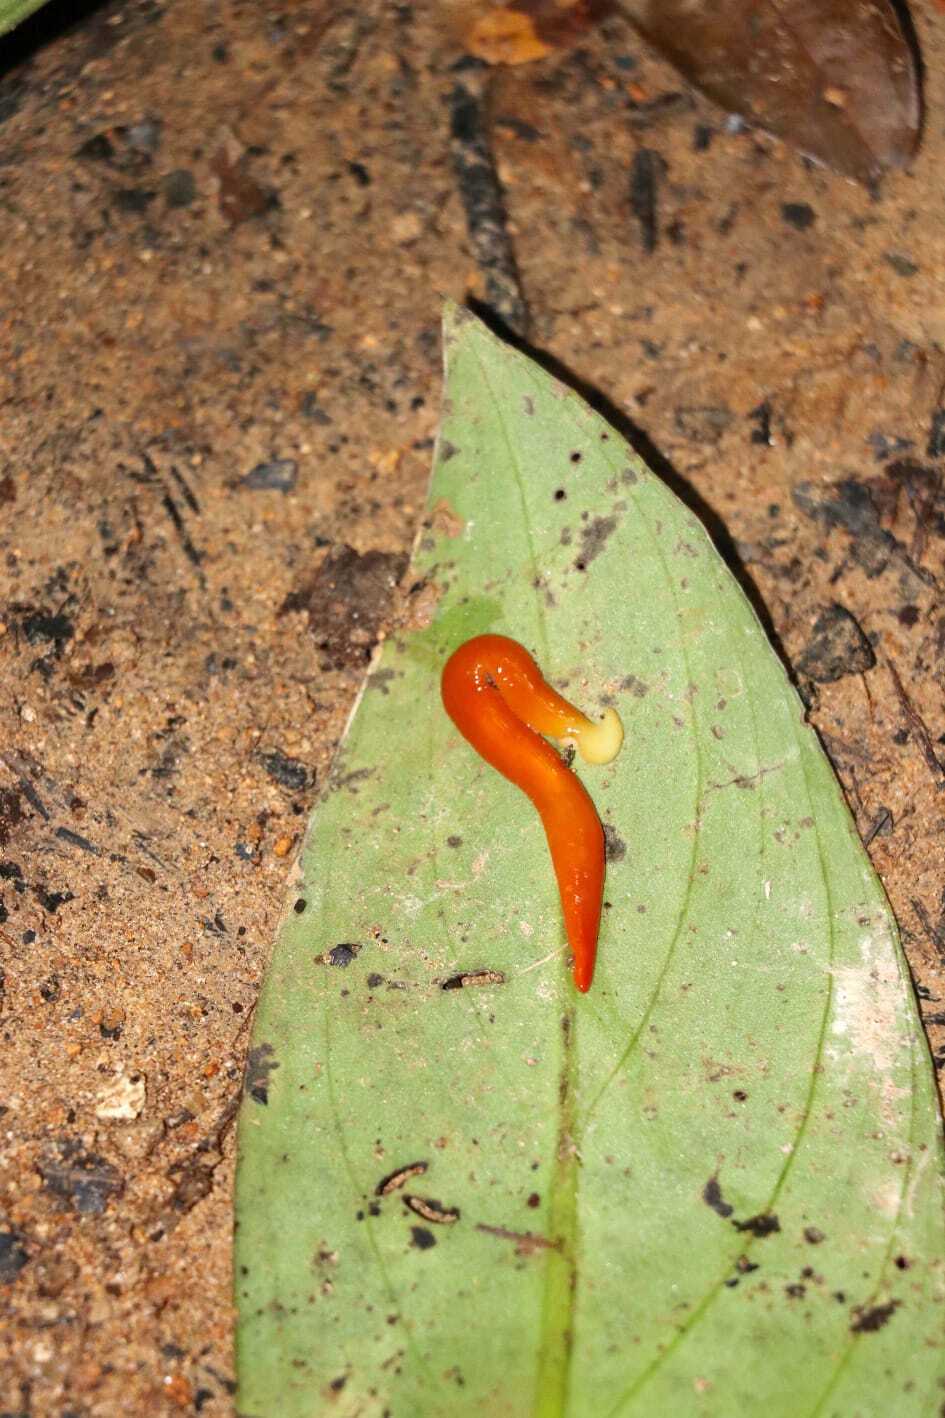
[{"left": 441, "top": 635, "right": 623, "bottom": 991}]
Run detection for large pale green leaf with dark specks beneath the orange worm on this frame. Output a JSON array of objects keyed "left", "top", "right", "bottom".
[{"left": 236, "top": 311, "right": 945, "bottom": 1418}]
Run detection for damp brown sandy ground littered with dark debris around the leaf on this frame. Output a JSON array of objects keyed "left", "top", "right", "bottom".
[{"left": 0, "top": 0, "right": 945, "bottom": 1418}]
